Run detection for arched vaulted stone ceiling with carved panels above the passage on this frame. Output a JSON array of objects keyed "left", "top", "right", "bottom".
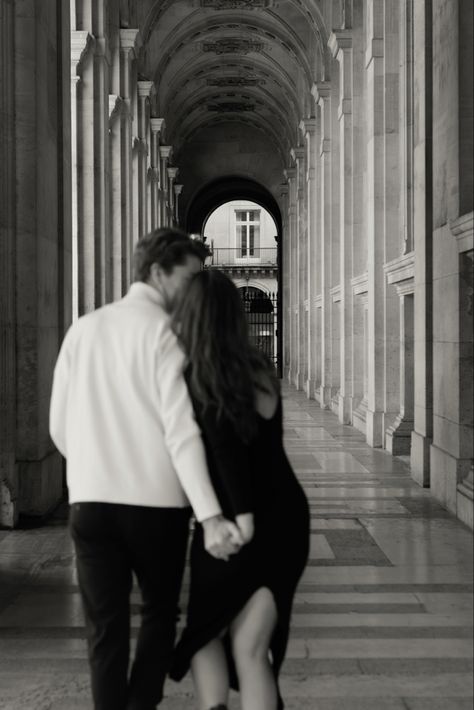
[{"left": 130, "top": 0, "right": 340, "bottom": 221}]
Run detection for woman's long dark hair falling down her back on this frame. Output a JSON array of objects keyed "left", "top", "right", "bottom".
[{"left": 173, "top": 269, "right": 276, "bottom": 442}]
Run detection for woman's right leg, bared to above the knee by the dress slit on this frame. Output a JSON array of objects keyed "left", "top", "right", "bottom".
[{"left": 230, "top": 587, "right": 278, "bottom": 710}]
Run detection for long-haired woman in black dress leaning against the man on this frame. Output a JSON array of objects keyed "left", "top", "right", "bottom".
[{"left": 171, "top": 270, "right": 309, "bottom": 710}]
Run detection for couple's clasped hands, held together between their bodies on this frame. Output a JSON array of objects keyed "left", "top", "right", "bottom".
[{"left": 202, "top": 513, "right": 254, "bottom": 561}]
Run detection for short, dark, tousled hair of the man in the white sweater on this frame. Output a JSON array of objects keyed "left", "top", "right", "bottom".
[{"left": 133, "top": 228, "right": 209, "bottom": 281}]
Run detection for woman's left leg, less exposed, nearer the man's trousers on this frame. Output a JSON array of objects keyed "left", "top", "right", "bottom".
[{"left": 191, "top": 639, "right": 229, "bottom": 710}]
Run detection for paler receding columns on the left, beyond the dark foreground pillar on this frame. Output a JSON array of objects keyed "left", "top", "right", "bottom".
[{"left": 71, "top": 0, "right": 182, "bottom": 317}]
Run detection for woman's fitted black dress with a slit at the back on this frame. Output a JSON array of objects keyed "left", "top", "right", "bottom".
[{"left": 170, "top": 392, "right": 309, "bottom": 708}]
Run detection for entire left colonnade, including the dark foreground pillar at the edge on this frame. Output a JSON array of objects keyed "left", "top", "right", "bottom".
[{"left": 0, "top": 0, "right": 182, "bottom": 527}]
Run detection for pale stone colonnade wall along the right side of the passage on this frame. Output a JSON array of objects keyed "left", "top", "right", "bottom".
[{"left": 281, "top": 0, "right": 474, "bottom": 526}]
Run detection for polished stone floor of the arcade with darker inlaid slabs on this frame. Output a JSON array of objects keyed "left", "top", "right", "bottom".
[{"left": 0, "top": 391, "right": 473, "bottom": 710}]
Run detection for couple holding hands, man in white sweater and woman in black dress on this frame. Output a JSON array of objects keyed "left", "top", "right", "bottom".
[{"left": 50, "top": 229, "right": 309, "bottom": 710}]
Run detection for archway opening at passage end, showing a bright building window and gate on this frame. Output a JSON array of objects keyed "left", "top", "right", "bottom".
[{"left": 186, "top": 177, "right": 282, "bottom": 376}]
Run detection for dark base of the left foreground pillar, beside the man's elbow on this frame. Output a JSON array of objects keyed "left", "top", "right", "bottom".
[{"left": 18, "top": 451, "right": 63, "bottom": 517}]
